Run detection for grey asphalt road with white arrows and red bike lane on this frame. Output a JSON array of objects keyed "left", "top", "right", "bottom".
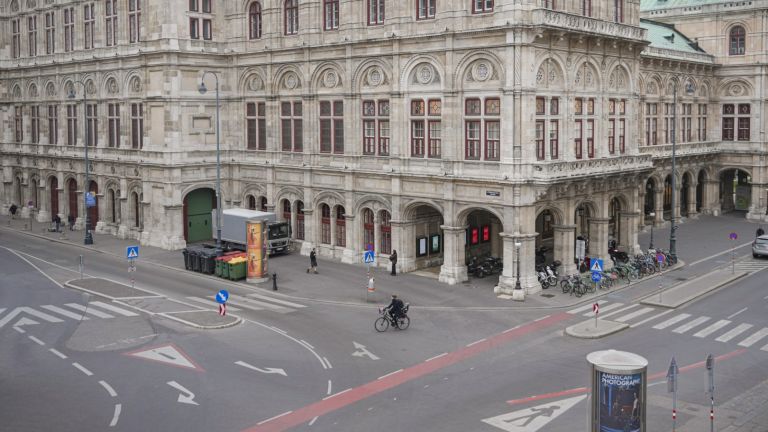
[{"left": 0, "top": 226, "right": 768, "bottom": 432}]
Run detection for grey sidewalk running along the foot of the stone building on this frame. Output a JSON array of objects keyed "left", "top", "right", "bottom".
[{"left": 0, "top": 215, "right": 757, "bottom": 310}]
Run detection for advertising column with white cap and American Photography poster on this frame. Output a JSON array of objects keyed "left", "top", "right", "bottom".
[{"left": 587, "top": 350, "right": 648, "bottom": 432}]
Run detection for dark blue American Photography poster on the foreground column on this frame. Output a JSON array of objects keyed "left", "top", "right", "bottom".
[{"left": 597, "top": 371, "right": 644, "bottom": 432}]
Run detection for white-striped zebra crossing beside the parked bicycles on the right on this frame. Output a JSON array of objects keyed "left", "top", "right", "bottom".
[{"left": 568, "top": 300, "right": 768, "bottom": 352}]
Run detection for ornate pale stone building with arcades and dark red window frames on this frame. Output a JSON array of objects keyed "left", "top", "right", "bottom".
[{"left": 0, "top": 0, "right": 768, "bottom": 293}]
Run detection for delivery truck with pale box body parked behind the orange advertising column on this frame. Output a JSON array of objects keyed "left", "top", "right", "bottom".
[{"left": 213, "top": 208, "right": 291, "bottom": 255}]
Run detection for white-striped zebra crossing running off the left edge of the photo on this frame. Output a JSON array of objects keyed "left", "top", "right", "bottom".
[{"left": 0, "top": 301, "right": 139, "bottom": 328}]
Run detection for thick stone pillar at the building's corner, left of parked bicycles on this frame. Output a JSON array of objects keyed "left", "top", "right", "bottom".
[{"left": 493, "top": 233, "right": 541, "bottom": 300}]
